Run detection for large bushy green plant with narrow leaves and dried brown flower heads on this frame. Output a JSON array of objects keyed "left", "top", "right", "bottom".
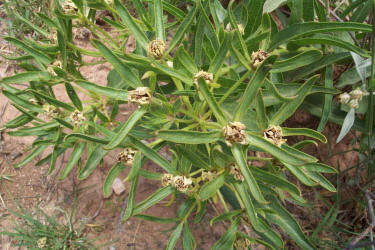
[{"left": 0, "top": 0, "right": 372, "bottom": 249}]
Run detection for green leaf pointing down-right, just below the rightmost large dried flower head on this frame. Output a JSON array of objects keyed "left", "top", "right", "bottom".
[{"left": 247, "top": 132, "right": 306, "bottom": 166}]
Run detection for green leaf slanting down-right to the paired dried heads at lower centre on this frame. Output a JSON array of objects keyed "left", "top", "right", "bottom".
[{"left": 129, "top": 136, "right": 177, "bottom": 174}]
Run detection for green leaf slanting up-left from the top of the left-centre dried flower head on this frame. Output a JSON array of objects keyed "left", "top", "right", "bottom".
[{"left": 91, "top": 39, "right": 143, "bottom": 88}]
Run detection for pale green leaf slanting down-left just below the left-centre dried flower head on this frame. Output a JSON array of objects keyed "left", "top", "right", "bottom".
[{"left": 104, "top": 107, "right": 147, "bottom": 150}]
